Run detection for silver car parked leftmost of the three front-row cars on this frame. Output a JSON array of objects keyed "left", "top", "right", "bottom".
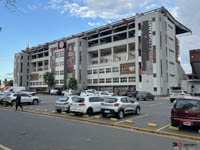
[{"left": 55, "top": 96, "right": 75, "bottom": 112}]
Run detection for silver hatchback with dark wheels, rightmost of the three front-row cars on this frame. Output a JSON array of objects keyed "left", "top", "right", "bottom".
[{"left": 101, "top": 96, "right": 141, "bottom": 119}]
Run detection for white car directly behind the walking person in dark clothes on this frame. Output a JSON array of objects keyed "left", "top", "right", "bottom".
[{"left": 3, "top": 93, "right": 40, "bottom": 106}]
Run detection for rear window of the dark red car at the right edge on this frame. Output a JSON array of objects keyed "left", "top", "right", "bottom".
[{"left": 174, "top": 100, "right": 200, "bottom": 110}]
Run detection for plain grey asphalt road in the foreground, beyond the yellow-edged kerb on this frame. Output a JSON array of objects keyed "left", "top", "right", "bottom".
[{"left": 0, "top": 109, "right": 200, "bottom": 150}]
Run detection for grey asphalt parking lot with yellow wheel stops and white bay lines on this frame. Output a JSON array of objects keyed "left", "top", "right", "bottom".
[{"left": 0, "top": 95, "right": 200, "bottom": 141}]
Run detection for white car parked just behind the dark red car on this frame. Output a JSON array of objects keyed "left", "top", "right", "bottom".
[{"left": 170, "top": 90, "right": 190, "bottom": 103}]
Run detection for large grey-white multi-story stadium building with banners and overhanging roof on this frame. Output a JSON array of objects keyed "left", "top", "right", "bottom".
[{"left": 15, "top": 7, "right": 191, "bottom": 95}]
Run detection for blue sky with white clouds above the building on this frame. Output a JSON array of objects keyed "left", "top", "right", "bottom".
[{"left": 0, "top": 0, "right": 200, "bottom": 80}]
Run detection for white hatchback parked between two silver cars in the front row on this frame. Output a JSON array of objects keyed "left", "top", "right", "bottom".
[{"left": 70, "top": 96, "right": 104, "bottom": 115}]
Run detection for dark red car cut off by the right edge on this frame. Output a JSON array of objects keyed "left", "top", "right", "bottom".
[{"left": 171, "top": 97, "right": 200, "bottom": 128}]
